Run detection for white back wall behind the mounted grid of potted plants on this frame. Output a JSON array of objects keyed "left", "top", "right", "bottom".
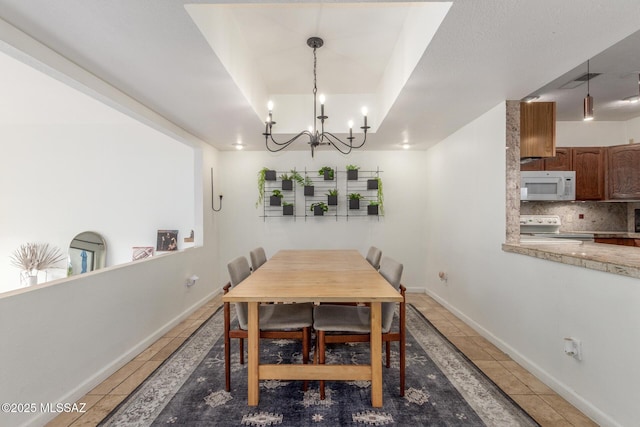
[{"left": 219, "top": 148, "right": 425, "bottom": 289}]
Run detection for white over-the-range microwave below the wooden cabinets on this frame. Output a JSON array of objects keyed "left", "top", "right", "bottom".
[{"left": 520, "top": 171, "right": 576, "bottom": 200}]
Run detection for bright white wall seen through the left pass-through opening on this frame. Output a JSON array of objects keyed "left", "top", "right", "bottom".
[{"left": 0, "top": 120, "right": 195, "bottom": 292}]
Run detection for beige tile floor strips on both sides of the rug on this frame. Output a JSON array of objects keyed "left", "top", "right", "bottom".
[{"left": 47, "top": 293, "right": 597, "bottom": 427}]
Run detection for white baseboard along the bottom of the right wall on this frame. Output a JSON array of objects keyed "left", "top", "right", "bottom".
[{"left": 419, "top": 288, "right": 622, "bottom": 427}]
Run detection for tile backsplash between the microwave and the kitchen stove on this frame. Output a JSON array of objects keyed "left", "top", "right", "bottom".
[{"left": 520, "top": 202, "right": 628, "bottom": 232}]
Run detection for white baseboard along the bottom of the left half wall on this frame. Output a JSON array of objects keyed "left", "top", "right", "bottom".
[{"left": 28, "top": 289, "right": 222, "bottom": 427}]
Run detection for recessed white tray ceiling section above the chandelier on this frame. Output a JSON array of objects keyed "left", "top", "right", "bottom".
[{"left": 185, "top": 2, "right": 451, "bottom": 134}]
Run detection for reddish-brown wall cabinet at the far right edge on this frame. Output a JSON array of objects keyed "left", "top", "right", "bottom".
[{"left": 607, "top": 144, "right": 640, "bottom": 200}]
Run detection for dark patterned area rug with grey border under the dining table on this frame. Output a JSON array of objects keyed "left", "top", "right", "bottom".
[{"left": 101, "top": 305, "right": 538, "bottom": 427}]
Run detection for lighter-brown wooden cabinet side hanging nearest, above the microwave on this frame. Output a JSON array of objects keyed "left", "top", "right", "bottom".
[{"left": 520, "top": 102, "right": 556, "bottom": 158}]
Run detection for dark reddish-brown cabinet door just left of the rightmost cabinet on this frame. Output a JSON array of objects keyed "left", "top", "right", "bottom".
[{"left": 571, "top": 147, "right": 606, "bottom": 200}]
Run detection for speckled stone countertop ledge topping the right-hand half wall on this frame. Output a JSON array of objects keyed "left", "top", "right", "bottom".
[{"left": 502, "top": 242, "right": 640, "bottom": 279}]
